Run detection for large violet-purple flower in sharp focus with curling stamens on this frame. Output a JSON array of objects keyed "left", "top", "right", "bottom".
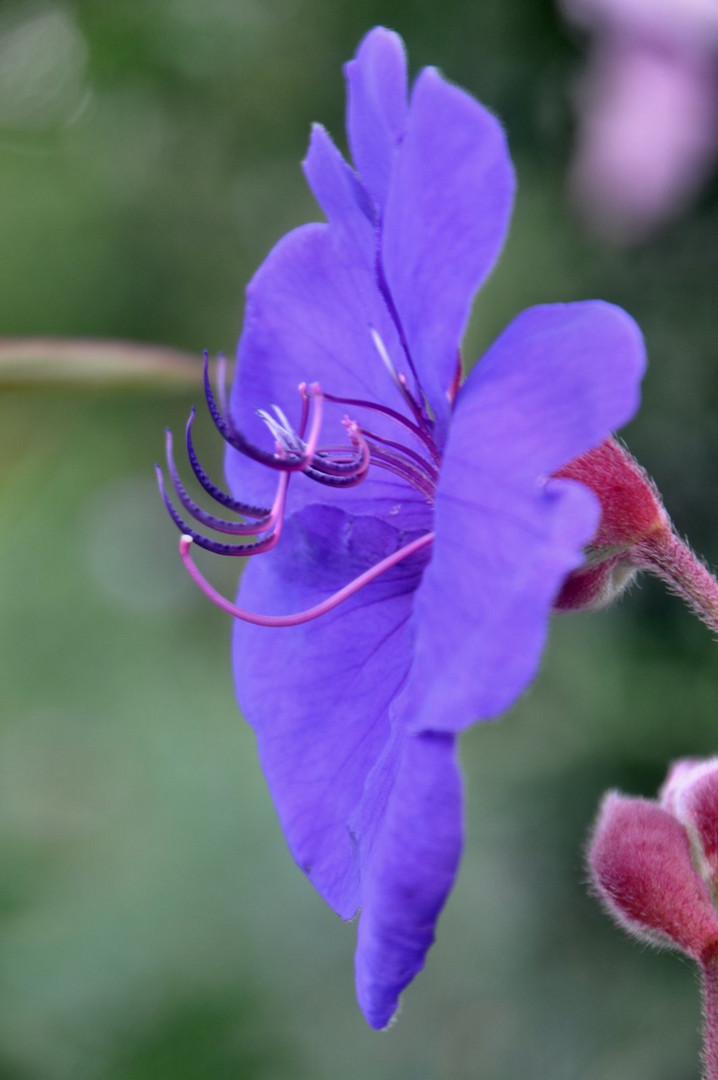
[{"left": 159, "top": 28, "right": 644, "bottom": 1028}]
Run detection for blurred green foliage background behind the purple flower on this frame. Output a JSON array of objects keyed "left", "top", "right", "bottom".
[{"left": 0, "top": 0, "right": 718, "bottom": 1080}]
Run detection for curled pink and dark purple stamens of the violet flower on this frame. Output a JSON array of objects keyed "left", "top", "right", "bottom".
[{"left": 155, "top": 349, "right": 441, "bottom": 626}]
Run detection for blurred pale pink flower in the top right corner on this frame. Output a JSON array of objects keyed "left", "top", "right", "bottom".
[{"left": 560, "top": 0, "right": 718, "bottom": 242}]
